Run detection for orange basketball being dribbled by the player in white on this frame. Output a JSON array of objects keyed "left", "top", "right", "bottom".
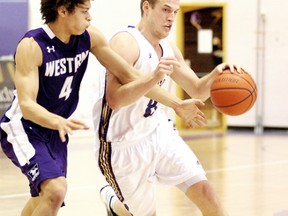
[{"left": 210, "top": 69, "right": 257, "bottom": 116}]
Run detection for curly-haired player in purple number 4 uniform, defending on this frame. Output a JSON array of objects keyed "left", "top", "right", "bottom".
[{"left": 0, "top": 0, "right": 177, "bottom": 216}]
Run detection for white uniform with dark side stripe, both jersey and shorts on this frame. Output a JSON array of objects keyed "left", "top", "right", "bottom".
[{"left": 94, "top": 27, "right": 207, "bottom": 213}]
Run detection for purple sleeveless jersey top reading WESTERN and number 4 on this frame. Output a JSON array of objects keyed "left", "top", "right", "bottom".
[{"left": 24, "top": 26, "right": 90, "bottom": 118}]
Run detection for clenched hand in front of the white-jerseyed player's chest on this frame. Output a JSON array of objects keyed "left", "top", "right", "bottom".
[{"left": 154, "top": 57, "right": 180, "bottom": 81}]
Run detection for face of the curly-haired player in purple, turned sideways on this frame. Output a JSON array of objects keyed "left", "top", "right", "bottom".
[{"left": 67, "top": 1, "right": 92, "bottom": 35}]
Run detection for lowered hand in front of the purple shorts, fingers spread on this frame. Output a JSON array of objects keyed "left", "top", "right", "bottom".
[{"left": 57, "top": 118, "right": 89, "bottom": 142}]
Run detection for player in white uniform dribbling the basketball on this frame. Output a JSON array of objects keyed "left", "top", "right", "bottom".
[{"left": 94, "top": 0, "right": 240, "bottom": 216}]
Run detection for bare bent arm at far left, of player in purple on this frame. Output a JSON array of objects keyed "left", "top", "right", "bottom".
[{"left": 14, "top": 38, "right": 88, "bottom": 141}]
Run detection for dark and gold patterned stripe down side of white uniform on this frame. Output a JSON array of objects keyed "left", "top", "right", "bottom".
[{"left": 98, "top": 96, "right": 124, "bottom": 201}]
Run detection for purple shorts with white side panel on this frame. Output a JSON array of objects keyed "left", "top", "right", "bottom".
[{"left": 0, "top": 117, "right": 68, "bottom": 197}]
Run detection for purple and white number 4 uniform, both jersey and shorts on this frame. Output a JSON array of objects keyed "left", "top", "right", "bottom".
[{"left": 0, "top": 25, "right": 90, "bottom": 196}]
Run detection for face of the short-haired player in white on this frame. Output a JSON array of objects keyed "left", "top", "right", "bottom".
[{"left": 148, "top": 0, "right": 179, "bottom": 39}]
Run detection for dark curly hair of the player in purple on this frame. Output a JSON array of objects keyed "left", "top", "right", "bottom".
[{"left": 40, "top": 0, "right": 88, "bottom": 24}]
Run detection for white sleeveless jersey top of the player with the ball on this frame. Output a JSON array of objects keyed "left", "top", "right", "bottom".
[{"left": 93, "top": 26, "right": 174, "bottom": 142}]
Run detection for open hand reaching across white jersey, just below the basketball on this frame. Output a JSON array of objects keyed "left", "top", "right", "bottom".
[{"left": 174, "top": 99, "right": 207, "bottom": 127}]
